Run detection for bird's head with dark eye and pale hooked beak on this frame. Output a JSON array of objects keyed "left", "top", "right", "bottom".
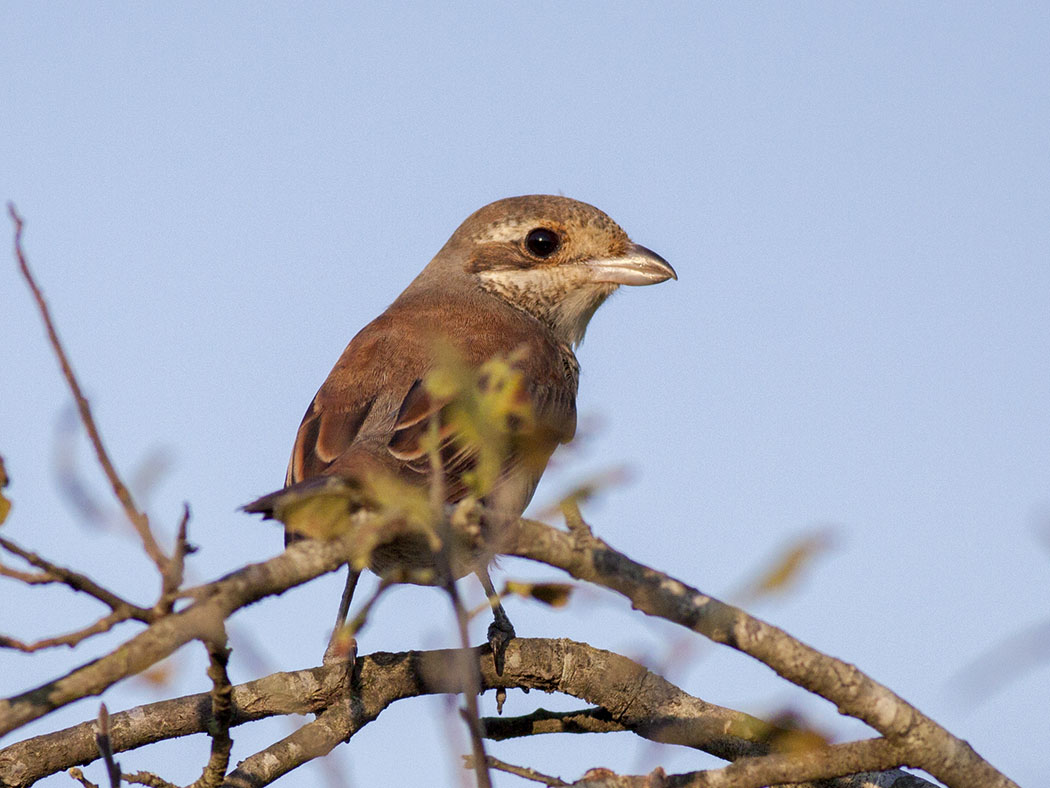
[{"left": 415, "top": 194, "right": 677, "bottom": 346}]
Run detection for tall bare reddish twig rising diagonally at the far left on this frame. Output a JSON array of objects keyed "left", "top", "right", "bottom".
[{"left": 7, "top": 203, "right": 169, "bottom": 575}]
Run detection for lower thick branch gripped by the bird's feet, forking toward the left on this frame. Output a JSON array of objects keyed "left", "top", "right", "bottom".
[{"left": 0, "top": 639, "right": 928, "bottom": 788}]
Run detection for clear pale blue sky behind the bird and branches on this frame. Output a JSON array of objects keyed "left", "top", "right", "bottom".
[{"left": 0, "top": 2, "right": 1050, "bottom": 786}]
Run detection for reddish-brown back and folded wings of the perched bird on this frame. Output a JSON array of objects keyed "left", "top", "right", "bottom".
[{"left": 286, "top": 299, "right": 576, "bottom": 507}]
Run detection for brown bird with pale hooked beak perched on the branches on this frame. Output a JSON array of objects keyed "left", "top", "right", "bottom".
[{"left": 243, "top": 194, "right": 677, "bottom": 672}]
